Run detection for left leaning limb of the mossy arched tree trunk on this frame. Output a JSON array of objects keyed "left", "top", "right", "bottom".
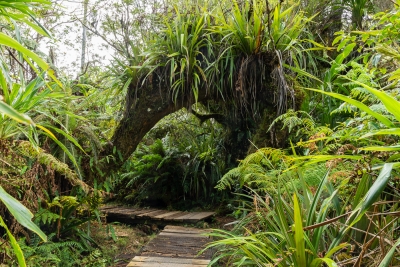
[{"left": 100, "top": 76, "right": 208, "bottom": 174}]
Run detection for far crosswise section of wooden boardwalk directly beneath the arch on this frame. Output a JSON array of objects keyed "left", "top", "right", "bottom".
[{"left": 100, "top": 206, "right": 215, "bottom": 225}]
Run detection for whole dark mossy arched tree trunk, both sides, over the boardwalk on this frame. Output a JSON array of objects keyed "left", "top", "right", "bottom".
[{"left": 94, "top": 54, "right": 292, "bottom": 180}]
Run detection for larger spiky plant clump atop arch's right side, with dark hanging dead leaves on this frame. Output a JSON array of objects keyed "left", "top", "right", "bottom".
[{"left": 208, "top": 1, "right": 311, "bottom": 114}]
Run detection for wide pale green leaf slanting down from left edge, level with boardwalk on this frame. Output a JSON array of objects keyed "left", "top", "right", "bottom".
[{"left": 0, "top": 186, "right": 47, "bottom": 241}]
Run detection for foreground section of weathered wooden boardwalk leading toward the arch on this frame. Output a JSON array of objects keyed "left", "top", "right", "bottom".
[{"left": 127, "top": 225, "right": 212, "bottom": 267}]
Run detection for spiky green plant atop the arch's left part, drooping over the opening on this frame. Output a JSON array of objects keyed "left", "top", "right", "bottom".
[{"left": 143, "top": 7, "right": 209, "bottom": 102}]
